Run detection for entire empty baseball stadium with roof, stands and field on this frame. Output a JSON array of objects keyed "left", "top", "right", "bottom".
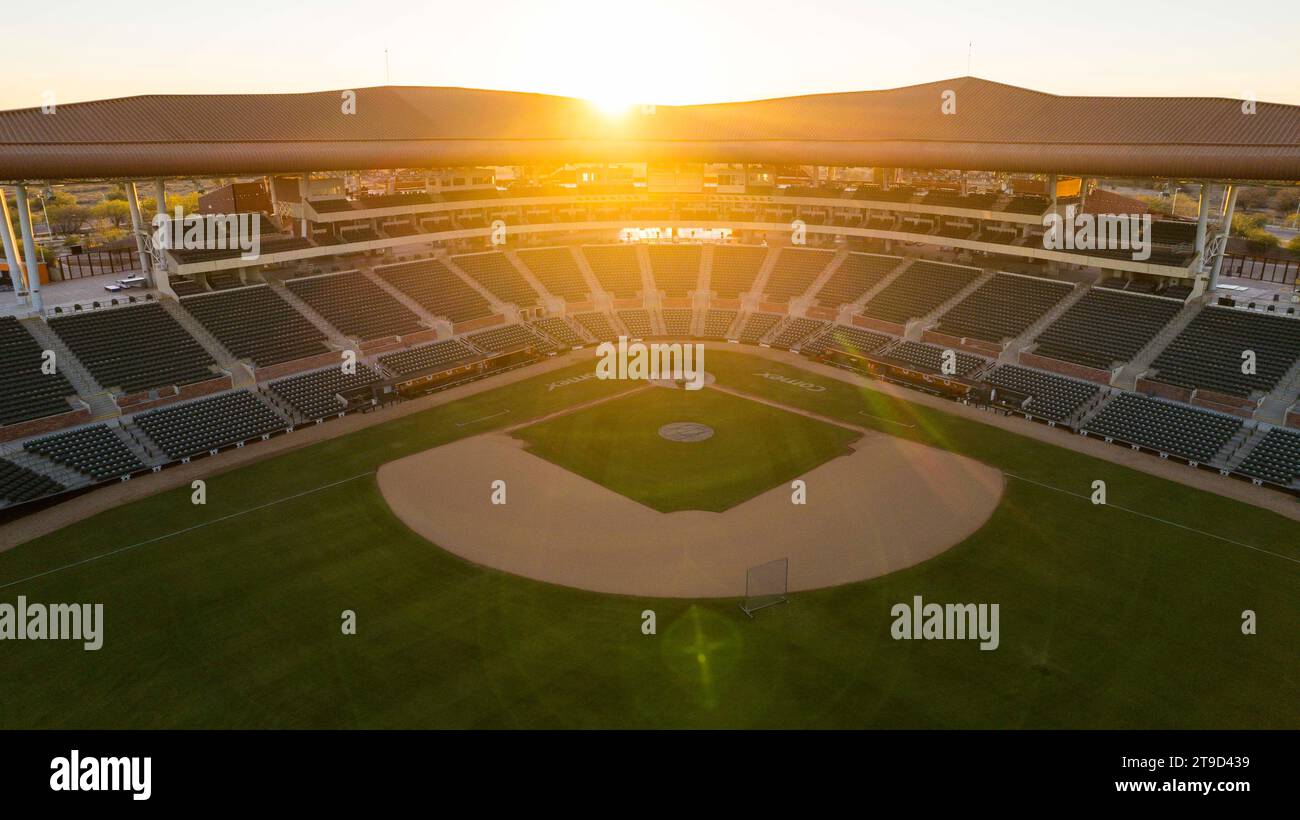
[{"left": 0, "top": 77, "right": 1300, "bottom": 729}]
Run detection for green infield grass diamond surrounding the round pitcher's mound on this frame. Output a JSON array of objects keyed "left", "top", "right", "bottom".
[{"left": 515, "top": 389, "right": 858, "bottom": 512}]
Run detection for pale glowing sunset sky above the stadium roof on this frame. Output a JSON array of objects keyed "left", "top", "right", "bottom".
[{"left": 0, "top": 0, "right": 1300, "bottom": 108}]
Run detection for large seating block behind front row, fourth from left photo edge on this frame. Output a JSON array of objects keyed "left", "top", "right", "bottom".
[{"left": 286, "top": 270, "right": 424, "bottom": 339}]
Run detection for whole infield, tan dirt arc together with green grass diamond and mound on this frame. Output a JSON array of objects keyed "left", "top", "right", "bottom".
[{"left": 378, "top": 390, "right": 1002, "bottom": 598}]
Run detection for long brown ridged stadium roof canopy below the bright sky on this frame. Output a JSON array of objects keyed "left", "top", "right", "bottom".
[{"left": 0, "top": 77, "right": 1300, "bottom": 181}]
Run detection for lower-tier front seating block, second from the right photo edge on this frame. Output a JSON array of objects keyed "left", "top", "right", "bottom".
[{"left": 1086, "top": 392, "right": 1242, "bottom": 463}]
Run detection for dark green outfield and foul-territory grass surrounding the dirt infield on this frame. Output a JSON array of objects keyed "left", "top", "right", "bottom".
[{"left": 0, "top": 351, "right": 1300, "bottom": 728}]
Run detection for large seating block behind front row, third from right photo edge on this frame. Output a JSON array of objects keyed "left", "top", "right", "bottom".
[{"left": 935, "top": 273, "right": 1074, "bottom": 342}]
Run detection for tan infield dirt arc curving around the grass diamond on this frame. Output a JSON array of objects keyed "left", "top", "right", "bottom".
[{"left": 378, "top": 433, "right": 1002, "bottom": 598}]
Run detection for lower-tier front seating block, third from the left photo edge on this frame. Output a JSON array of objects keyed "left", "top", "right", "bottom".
[{"left": 133, "top": 390, "right": 285, "bottom": 459}]
